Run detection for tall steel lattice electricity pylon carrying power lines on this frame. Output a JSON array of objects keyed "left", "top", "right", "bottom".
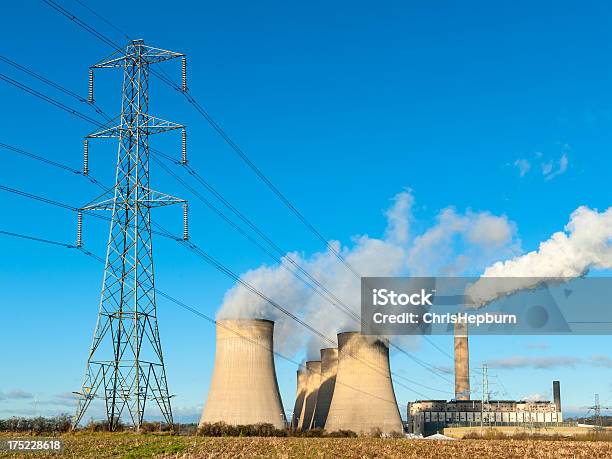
[{"left": 73, "top": 40, "right": 188, "bottom": 430}]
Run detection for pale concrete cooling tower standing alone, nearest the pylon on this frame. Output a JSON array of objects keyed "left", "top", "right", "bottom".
[{"left": 200, "top": 319, "right": 285, "bottom": 429}]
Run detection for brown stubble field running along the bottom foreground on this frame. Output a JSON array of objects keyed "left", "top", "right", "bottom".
[{"left": 0, "top": 433, "right": 612, "bottom": 459}]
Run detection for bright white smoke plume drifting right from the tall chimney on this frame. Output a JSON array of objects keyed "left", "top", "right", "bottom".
[{"left": 466, "top": 206, "right": 612, "bottom": 306}]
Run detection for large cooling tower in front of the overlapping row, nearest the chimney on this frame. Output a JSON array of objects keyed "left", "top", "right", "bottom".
[{"left": 325, "top": 332, "right": 403, "bottom": 434}]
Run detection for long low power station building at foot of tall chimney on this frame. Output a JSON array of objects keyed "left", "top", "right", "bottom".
[{"left": 407, "top": 381, "right": 563, "bottom": 436}]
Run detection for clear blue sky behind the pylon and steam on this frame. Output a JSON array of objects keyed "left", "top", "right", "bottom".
[{"left": 0, "top": 0, "right": 612, "bottom": 419}]
